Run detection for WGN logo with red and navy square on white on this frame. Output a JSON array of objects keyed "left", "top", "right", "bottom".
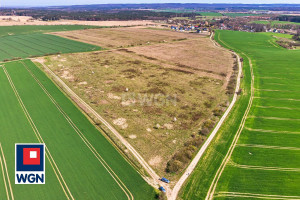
[{"left": 15, "top": 144, "right": 45, "bottom": 184}]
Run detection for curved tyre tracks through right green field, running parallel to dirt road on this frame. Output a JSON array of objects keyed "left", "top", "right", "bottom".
[{"left": 205, "top": 31, "right": 254, "bottom": 200}]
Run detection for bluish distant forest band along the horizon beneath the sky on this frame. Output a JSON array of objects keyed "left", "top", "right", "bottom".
[{"left": 0, "top": 3, "right": 300, "bottom": 22}]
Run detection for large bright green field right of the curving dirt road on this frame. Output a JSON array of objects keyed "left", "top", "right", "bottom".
[{"left": 181, "top": 31, "right": 300, "bottom": 199}]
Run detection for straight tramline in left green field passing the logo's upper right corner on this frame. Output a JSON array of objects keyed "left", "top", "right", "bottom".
[{"left": 2, "top": 67, "right": 74, "bottom": 200}]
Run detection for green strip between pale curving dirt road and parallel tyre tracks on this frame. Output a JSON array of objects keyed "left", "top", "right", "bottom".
[{"left": 179, "top": 31, "right": 251, "bottom": 199}]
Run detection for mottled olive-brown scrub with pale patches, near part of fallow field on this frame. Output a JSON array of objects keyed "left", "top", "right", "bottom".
[{"left": 45, "top": 48, "right": 227, "bottom": 175}]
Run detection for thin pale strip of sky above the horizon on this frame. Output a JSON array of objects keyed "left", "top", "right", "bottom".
[{"left": 0, "top": 0, "right": 300, "bottom": 7}]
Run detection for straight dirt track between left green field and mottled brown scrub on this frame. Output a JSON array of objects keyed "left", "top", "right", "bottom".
[{"left": 33, "top": 62, "right": 160, "bottom": 187}]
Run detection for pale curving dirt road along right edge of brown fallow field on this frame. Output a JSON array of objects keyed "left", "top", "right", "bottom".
[{"left": 169, "top": 33, "right": 242, "bottom": 200}]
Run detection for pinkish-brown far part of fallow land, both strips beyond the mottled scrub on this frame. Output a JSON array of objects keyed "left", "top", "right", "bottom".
[{"left": 52, "top": 28, "right": 233, "bottom": 81}]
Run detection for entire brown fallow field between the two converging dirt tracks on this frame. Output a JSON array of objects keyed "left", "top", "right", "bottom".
[{"left": 43, "top": 28, "right": 234, "bottom": 180}]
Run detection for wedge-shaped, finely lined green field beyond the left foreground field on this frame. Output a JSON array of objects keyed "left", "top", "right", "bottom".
[{"left": 0, "top": 33, "right": 101, "bottom": 61}]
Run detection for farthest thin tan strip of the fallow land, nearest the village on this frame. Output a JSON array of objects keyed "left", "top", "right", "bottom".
[{"left": 51, "top": 28, "right": 199, "bottom": 48}]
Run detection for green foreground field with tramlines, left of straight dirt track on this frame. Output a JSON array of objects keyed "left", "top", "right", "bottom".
[{"left": 0, "top": 60, "right": 155, "bottom": 200}]
